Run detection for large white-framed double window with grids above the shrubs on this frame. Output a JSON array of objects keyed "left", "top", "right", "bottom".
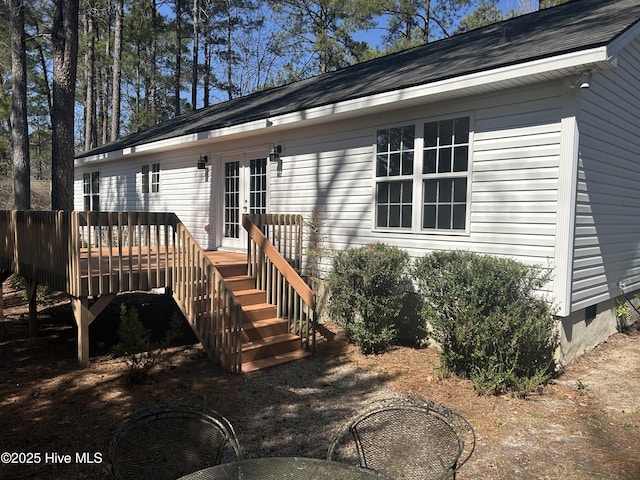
[{"left": 375, "top": 117, "right": 470, "bottom": 231}]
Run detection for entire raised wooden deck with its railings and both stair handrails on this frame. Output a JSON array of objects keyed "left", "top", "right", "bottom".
[{"left": 0, "top": 211, "right": 315, "bottom": 372}]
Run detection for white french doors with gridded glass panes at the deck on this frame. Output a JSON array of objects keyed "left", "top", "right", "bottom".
[{"left": 220, "top": 157, "right": 268, "bottom": 251}]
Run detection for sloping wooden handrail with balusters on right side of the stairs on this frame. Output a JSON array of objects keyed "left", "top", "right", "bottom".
[{"left": 242, "top": 214, "right": 316, "bottom": 349}]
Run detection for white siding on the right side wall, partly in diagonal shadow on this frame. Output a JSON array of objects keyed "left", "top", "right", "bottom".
[{"left": 572, "top": 35, "right": 640, "bottom": 310}]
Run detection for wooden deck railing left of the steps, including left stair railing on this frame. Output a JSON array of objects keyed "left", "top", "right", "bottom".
[{"left": 0, "top": 211, "right": 241, "bottom": 372}]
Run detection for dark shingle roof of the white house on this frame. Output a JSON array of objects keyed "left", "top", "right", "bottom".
[{"left": 81, "top": 0, "right": 640, "bottom": 157}]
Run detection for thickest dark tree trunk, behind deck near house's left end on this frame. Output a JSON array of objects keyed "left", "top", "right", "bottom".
[{"left": 51, "top": 0, "right": 79, "bottom": 211}]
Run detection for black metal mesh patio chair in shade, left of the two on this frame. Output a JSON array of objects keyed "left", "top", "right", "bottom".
[{"left": 109, "top": 406, "right": 242, "bottom": 480}]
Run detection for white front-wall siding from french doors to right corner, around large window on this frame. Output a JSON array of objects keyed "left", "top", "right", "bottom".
[{"left": 271, "top": 83, "right": 562, "bottom": 282}]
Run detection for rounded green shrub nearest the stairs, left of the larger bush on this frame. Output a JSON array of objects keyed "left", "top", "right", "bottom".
[{"left": 328, "top": 243, "right": 411, "bottom": 354}]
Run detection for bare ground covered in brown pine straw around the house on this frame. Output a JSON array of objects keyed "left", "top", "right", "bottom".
[{"left": 0, "top": 284, "right": 640, "bottom": 480}]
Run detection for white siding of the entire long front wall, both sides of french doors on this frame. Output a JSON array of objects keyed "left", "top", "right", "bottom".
[{"left": 77, "top": 82, "right": 562, "bottom": 310}]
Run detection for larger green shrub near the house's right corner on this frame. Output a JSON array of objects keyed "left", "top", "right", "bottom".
[{"left": 414, "top": 251, "right": 557, "bottom": 395}]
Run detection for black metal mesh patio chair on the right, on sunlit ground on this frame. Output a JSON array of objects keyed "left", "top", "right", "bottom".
[{"left": 327, "top": 398, "right": 475, "bottom": 480}]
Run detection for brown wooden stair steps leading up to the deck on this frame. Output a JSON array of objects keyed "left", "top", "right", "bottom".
[{"left": 216, "top": 263, "right": 311, "bottom": 372}]
